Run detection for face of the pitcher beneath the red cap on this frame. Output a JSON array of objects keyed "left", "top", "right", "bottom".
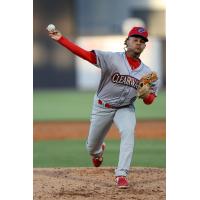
[{"left": 127, "top": 37, "right": 146, "bottom": 54}]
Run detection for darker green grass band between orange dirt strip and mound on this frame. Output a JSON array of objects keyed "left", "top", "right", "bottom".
[{"left": 33, "top": 140, "right": 166, "bottom": 168}]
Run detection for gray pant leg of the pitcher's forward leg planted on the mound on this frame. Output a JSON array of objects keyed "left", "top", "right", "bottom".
[{"left": 114, "top": 106, "right": 136, "bottom": 176}]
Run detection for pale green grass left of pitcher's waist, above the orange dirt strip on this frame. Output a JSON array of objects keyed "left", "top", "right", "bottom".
[{"left": 33, "top": 90, "right": 94, "bottom": 120}]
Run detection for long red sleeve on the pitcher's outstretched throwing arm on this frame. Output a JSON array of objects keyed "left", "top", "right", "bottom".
[{"left": 58, "top": 36, "right": 97, "bottom": 64}]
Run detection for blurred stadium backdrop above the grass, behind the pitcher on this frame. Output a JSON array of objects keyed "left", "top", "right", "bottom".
[{"left": 33, "top": 0, "right": 166, "bottom": 89}]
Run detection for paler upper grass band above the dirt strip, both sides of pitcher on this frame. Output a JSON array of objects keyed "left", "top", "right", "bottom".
[{"left": 33, "top": 90, "right": 166, "bottom": 121}]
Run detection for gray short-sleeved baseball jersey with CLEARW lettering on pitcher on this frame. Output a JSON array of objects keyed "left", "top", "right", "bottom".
[{"left": 94, "top": 50, "right": 158, "bottom": 107}]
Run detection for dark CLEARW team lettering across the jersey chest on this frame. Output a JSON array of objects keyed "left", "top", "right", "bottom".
[{"left": 111, "top": 73, "right": 139, "bottom": 90}]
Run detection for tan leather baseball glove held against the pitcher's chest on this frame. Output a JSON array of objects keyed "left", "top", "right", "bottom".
[{"left": 137, "top": 72, "right": 158, "bottom": 99}]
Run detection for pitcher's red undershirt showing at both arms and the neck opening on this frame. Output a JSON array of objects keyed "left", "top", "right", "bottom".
[{"left": 58, "top": 36, "right": 156, "bottom": 105}]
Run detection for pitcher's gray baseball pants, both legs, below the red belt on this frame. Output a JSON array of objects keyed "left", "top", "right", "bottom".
[{"left": 86, "top": 95, "right": 136, "bottom": 176}]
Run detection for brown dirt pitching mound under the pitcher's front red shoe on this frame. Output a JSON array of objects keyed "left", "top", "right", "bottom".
[{"left": 33, "top": 167, "right": 166, "bottom": 200}]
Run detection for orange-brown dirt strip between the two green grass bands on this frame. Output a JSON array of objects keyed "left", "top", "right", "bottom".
[{"left": 33, "top": 120, "right": 166, "bottom": 141}]
